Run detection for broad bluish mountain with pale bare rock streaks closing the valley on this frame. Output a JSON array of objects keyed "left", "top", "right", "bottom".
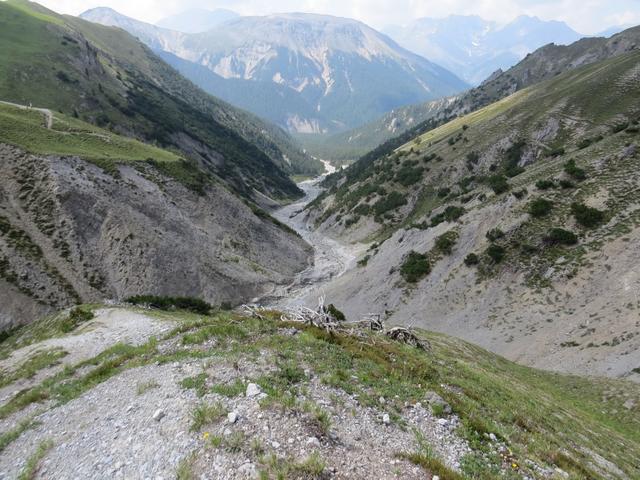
[{"left": 82, "top": 9, "right": 467, "bottom": 133}]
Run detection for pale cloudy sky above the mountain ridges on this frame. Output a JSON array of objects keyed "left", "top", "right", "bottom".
[{"left": 36, "top": 0, "right": 640, "bottom": 34}]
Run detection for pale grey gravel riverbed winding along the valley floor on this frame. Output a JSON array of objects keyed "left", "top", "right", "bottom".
[{"left": 260, "top": 160, "right": 364, "bottom": 308}]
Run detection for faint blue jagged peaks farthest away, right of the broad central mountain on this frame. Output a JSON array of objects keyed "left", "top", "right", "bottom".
[{"left": 385, "top": 15, "right": 582, "bottom": 84}]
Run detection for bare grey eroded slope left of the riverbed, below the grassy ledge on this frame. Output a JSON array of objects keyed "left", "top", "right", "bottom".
[{"left": 0, "top": 145, "right": 312, "bottom": 328}]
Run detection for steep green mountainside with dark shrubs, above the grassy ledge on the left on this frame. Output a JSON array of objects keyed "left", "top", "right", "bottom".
[{"left": 0, "top": 0, "right": 308, "bottom": 198}]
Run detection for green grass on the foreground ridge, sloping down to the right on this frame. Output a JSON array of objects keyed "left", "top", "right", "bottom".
[{"left": 0, "top": 306, "right": 640, "bottom": 480}]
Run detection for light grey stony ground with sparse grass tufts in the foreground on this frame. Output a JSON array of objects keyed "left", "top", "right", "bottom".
[{"left": 0, "top": 308, "right": 469, "bottom": 479}]
